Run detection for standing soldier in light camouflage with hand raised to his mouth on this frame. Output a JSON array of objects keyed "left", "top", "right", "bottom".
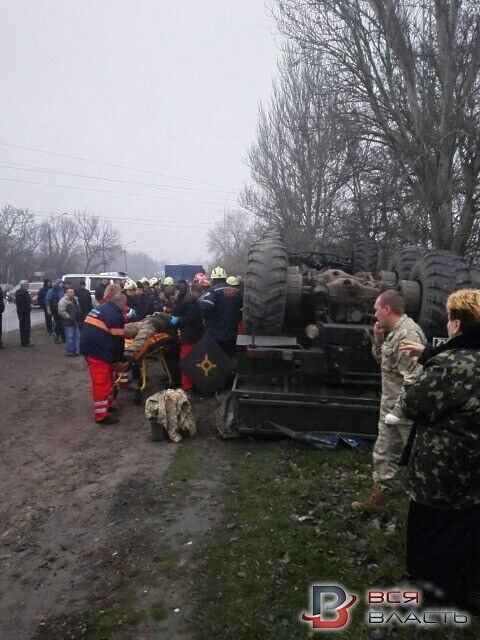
[{"left": 352, "top": 289, "right": 426, "bottom": 512}]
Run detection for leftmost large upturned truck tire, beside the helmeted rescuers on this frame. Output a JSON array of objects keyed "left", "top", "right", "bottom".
[{"left": 243, "top": 232, "right": 288, "bottom": 336}]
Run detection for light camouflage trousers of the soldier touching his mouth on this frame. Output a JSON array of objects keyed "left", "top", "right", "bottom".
[{"left": 373, "top": 411, "right": 412, "bottom": 490}]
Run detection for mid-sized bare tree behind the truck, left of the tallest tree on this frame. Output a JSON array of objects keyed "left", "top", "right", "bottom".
[{"left": 240, "top": 49, "right": 349, "bottom": 249}]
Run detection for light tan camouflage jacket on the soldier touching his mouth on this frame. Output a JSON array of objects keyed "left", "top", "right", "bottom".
[{"left": 372, "top": 314, "right": 427, "bottom": 419}]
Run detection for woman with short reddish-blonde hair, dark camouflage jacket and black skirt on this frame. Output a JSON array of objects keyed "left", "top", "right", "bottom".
[{"left": 401, "top": 289, "right": 480, "bottom": 615}]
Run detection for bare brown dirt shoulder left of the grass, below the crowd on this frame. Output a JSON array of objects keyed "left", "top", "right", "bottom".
[{"left": 0, "top": 329, "right": 226, "bottom": 640}]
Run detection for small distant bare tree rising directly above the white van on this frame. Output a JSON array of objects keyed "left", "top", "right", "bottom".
[{"left": 74, "top": 212, "right": 121, "bottom": 273}]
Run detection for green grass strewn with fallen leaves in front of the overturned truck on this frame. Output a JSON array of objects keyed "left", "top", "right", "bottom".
[{"left": 191, "top": 442, "right": 480, "bottom": 640}]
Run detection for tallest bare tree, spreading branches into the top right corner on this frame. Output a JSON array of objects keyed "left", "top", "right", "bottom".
[{"left": 278, "top": 0, "right": 480, "bottom": 253}]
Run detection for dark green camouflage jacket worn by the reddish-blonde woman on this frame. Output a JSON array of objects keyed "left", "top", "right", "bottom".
[{"left": 401, "top": 336, "right": 480, "bottom": 508}]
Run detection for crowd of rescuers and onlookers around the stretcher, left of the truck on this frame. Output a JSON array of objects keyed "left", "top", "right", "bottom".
[{"left": 0, "top": 267, "right": 243, "bottom": 424}]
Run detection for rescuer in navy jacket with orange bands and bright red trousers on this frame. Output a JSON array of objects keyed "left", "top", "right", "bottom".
[{"left": 80, "top": 292, "right": 126, "bottom": 425}]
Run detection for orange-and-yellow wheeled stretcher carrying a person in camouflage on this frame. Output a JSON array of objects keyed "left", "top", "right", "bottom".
[{"left": 113, "top": 332, "right": 172, "bottom": 404}]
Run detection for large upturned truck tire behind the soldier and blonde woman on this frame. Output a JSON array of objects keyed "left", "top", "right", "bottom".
[{"left": 409, "top": 249, "right": 471, "bottom": 340}]
